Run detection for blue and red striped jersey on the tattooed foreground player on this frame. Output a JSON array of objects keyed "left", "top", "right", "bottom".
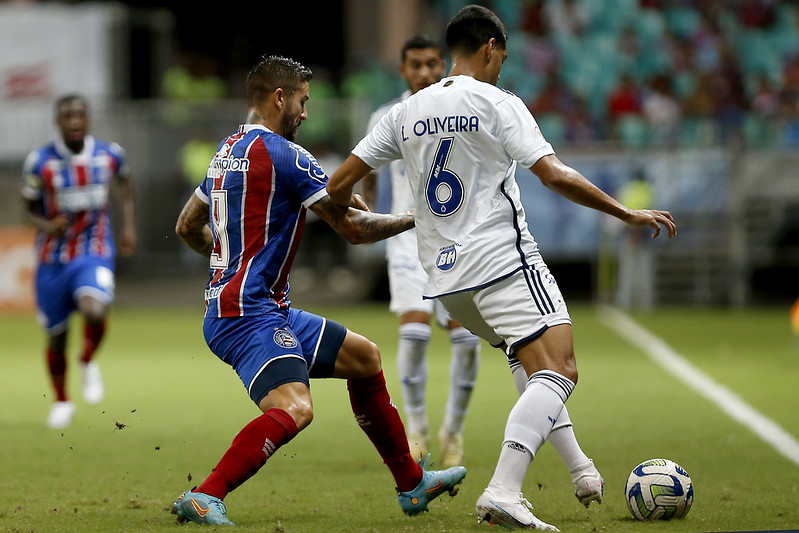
[{"left": 195, "top": 124, "right": 327, "bottom": 318}]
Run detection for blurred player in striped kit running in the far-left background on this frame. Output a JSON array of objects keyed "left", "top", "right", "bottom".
[{"left": 22, "top": 94, "right": 136, "bottom": 428}]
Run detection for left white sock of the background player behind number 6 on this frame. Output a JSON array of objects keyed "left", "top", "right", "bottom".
[{"left": 397, "top": 322, "right": 430, "bottom": 434}]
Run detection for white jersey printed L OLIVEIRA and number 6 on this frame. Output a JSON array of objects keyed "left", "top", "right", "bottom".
[{"left": 352, "top": 76, "right": 554, "bottom": 298}]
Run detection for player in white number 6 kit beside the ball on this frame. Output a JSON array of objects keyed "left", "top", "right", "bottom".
[{"left": 327, "top": 5, "right": 677, "bottom": 530}]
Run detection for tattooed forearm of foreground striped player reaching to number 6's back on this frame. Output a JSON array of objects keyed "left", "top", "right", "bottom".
[{"left": 310, "top": 195, "right": 414, "bottom": 244}]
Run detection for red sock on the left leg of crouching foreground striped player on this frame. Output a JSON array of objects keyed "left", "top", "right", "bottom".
[{"left": 197, "top": 409, "right": 299, "bottom": 500}]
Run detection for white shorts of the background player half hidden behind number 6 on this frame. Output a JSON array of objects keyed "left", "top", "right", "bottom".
[{"left": 386, "top": 230, "right": 449, "bottom": 327}]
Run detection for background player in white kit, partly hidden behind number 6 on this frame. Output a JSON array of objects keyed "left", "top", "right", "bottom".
[{"left": 364, "top": 36, "right": 480, "bottom": 468}]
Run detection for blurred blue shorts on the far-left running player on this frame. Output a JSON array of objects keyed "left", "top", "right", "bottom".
[{"left": 36, "top": 256, "right": 114, "bottom": 334}]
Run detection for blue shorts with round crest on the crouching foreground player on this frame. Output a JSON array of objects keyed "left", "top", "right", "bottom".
[{"left": 203, "top": 309, "right": 347, "bottom": 405}]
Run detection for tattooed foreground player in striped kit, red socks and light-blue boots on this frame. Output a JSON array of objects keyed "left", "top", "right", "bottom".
[{"left": 173, "top": 56, "right": 466, "bottom": 525}]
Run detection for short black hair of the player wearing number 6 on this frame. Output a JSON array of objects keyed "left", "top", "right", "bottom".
[{"left": 446, "top": 5, "right": 508, "bottom": 54}]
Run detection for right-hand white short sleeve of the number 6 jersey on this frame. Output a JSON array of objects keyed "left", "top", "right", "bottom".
[{"left": 496, "top": 91, "right": 555, "bottom": 168}]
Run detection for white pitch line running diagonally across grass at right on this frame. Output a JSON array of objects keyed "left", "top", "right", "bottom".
[{"left": 599, "top": 306, "right": 799, "bottom": 466}]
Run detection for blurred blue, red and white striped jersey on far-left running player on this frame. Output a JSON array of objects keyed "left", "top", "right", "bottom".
[{"left": 22, "top": 135, "right": 128, "bottom": 264}]
